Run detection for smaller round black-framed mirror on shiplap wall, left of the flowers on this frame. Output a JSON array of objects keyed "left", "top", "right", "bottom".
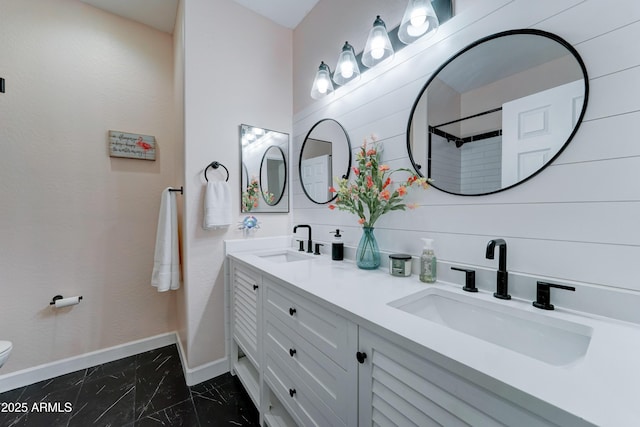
[{"left": 298, "top": 119, "right": 351, "bottom": 204}]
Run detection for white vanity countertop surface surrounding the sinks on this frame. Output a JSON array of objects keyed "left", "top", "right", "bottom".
[{"left": 227, "top": 242, "right": 640, "bottom": 427}]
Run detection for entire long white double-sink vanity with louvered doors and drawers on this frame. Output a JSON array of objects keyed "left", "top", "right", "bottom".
[{"left": 226, "top": 237, "right": 640, "bottom": 426}]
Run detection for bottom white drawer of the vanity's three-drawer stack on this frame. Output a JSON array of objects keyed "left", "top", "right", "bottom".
[{"left": 264, "top": 352, "right": 344, "bottom": 427}]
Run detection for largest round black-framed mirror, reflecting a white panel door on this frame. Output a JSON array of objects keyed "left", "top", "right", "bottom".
[{"left": 407, "top": 29, "right": 589, "bottom": 195}]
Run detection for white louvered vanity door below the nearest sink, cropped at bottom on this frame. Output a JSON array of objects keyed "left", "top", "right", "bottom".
[{"left": 357, "top": 328, "right": 556, "bottom": 427}]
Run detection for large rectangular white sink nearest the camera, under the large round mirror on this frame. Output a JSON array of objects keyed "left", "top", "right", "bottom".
[{"left": 388, "top": 288, "right": 593, "bottom": 366}]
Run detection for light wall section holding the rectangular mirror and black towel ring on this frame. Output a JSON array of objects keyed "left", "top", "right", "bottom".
[{"left": 183, "top": 0, "right": 292, "bottom": 368}]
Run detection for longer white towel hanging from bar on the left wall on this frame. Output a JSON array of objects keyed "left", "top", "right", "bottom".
[{"left": 151, "top": 188, "right": 180, "bottom": 292}]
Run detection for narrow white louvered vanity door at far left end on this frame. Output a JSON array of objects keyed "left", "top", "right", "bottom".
[{"left": 231, "top": 263, "right": 261, "bottom": 368}]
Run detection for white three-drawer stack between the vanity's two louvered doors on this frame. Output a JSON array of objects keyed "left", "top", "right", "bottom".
[{"left": 263, "top": 278, "right": 358, "bottom": 426}]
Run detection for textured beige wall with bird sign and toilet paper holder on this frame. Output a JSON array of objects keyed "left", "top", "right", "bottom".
[{"left": 0, "top": 0, "right": 180, "bottom": 374}]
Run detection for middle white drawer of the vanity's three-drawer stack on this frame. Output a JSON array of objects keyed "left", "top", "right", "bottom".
[{"left": 263, "top": 313, "right": 356, "bottom": 425}]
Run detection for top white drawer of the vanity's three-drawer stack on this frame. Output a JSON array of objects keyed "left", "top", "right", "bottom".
[{"left": 264, "top": 279, "right": 348, "bottom": 368}]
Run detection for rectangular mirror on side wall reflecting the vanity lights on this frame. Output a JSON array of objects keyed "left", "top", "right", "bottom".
[{"left": 240, "top": 124, "right": 289, "bottom": 213}]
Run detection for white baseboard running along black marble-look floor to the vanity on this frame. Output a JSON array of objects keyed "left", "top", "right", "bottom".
[{"left": 0, "top": 332, "right": 229, "bottom": 393}]
